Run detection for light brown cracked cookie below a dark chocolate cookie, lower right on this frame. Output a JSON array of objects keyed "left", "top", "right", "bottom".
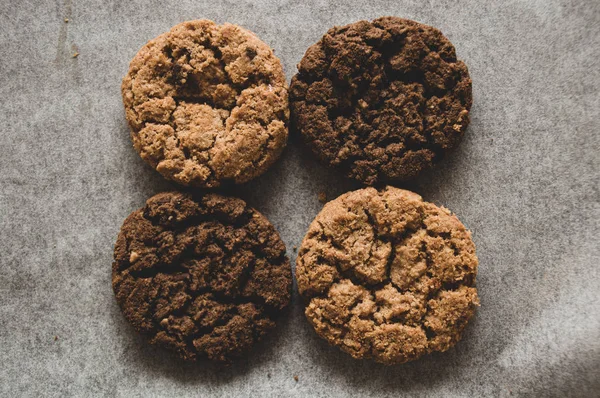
[{"left": 296, "top": 187, "right": 479, "bottom": 365}]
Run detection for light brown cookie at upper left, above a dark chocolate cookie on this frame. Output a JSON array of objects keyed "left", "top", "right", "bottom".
[{"left": 122, "top": 20, "right": 289, "bottom": 188}]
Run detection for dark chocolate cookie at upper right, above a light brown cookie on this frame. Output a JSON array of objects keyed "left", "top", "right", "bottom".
[{"left": 290, "top": 17, "right": 472, "bottom": 185}]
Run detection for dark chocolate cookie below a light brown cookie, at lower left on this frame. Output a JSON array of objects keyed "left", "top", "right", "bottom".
[{"left": 112, "top": 192, "right": 292, "bottom": 362}]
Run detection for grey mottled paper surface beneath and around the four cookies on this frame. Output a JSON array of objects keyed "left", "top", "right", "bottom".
[{"left": 0, "top": 0, "right": 600, "bottom": 397}]
